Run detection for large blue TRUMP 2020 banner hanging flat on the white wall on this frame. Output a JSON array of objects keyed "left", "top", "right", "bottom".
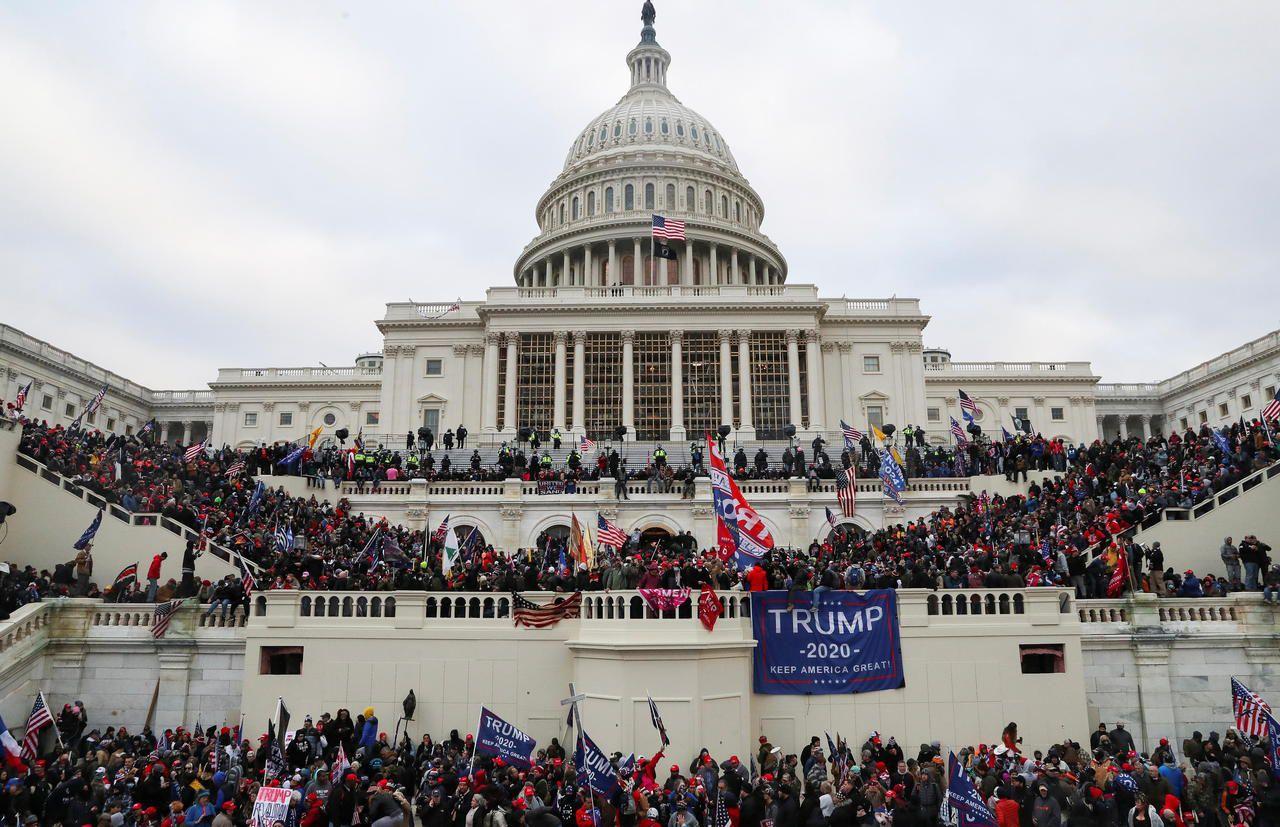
[{"left": 751, "top": 589, "right": 905, "bottom": 695}]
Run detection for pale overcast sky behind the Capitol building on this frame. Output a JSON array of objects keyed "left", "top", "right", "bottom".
[{"left": 0, "top": 0, "right": 1280, "bottom": 388}]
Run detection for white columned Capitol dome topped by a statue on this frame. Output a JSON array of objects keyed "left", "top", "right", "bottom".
[{"left": 515, "top": 5, "right": 787, "bottom": 287}]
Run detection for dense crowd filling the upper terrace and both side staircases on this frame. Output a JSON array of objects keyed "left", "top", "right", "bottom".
[{"left": 0, "top": 421, "right": 1280, "bottom": 619}]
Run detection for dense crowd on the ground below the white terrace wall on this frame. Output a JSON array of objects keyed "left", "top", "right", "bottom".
[{"left": 0, "top": 702, "right": 1280, "bottom": 827}]
